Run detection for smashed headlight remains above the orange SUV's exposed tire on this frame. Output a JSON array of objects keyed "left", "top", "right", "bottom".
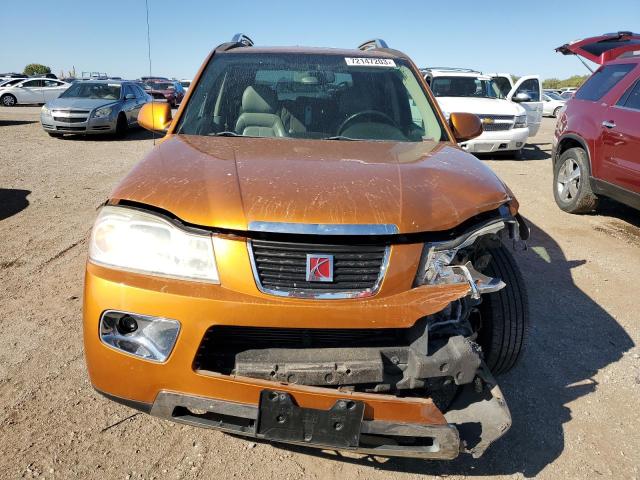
[{"left": 415, "top": 220, "right": 506, "bottom": 298}]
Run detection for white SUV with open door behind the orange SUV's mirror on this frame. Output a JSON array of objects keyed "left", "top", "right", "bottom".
[{"left": 423, "top": 68, "right": 542, "bottom": 153}]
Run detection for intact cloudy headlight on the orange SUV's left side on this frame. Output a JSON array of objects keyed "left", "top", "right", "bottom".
[{"left": 89, "top": 206, "right": 220, "bottom": 283}]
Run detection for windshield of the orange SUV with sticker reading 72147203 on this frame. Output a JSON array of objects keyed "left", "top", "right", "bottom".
[{"left": 176, "top": 53, "right": 448, "bottom": 142}]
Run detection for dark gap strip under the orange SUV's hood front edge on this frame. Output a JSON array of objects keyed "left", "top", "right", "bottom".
[{"left": 105, "top": 199, "right": 528, "bottom": 245}]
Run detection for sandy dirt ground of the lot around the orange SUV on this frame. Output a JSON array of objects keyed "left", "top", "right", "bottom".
[{"left": 0, "top": 107, "right": 640, "bottom": 480}]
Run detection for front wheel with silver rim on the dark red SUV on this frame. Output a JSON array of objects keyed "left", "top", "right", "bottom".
[{"left": 553, "top": 147, "right": 598, "bottom": 213}]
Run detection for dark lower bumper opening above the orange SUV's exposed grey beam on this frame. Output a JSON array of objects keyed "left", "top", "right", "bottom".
[{"left": 193, "top": 325, "right": 408, "bottom": 375}]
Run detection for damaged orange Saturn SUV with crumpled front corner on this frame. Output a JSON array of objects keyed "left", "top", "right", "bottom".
[{"left": 83, "top": 35, "right": 528, "bottom": 459}]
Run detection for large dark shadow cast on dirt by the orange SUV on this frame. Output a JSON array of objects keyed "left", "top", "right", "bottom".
[{"left": 258, "top": 219, "right": 634, "bottom": 478}]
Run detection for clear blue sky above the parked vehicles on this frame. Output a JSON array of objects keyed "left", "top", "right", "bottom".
[{"left": 0, "top": 0, "right": 640, "bottom": 78}]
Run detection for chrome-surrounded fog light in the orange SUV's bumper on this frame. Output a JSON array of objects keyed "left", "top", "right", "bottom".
[{"left": 100, "top": 310, "right": 180, "bottom": 362}]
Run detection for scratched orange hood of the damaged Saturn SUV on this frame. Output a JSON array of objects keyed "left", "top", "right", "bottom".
[{"left": 112, "top": 135, "right": 511, "bottom": 233}]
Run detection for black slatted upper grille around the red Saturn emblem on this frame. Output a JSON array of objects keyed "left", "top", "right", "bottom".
[{"left": 251, "top": 240, "right": 387, "bottom": 294}]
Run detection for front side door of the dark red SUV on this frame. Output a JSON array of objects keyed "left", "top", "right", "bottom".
[{"left": 602, "top": 79, "right": 640, "bottom": 193}]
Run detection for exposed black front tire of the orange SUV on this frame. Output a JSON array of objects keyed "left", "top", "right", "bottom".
[{"left": 478, "top": 245, "right": 529, "bottom": 375}]
